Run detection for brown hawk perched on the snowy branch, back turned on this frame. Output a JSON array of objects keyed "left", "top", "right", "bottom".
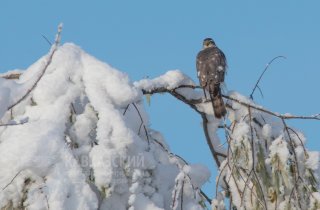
[{"left": 197, "top": 38, "right": 227, "bottom": 118}]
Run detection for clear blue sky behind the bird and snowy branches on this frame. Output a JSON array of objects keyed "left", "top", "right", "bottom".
[{"left": 0, "top": 0, "right": 320, "bottom": 199}]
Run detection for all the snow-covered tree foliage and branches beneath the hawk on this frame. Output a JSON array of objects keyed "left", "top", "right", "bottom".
[{"left": 0, "top": 29, "right": 320, "bottom": 210}]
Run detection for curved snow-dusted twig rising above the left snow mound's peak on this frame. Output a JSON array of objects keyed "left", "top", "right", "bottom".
[{"left": 7, "top": 24, "right": 62, "bottom": 110}]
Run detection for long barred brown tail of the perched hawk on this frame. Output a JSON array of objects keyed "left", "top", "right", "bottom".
[{"left": 210, "top": 87, "right": 227, "bottom": 119}]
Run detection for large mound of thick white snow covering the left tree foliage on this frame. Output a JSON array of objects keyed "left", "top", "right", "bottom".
[{"left": 0, "top": 27, "right": 210, "bottom": 210}]
